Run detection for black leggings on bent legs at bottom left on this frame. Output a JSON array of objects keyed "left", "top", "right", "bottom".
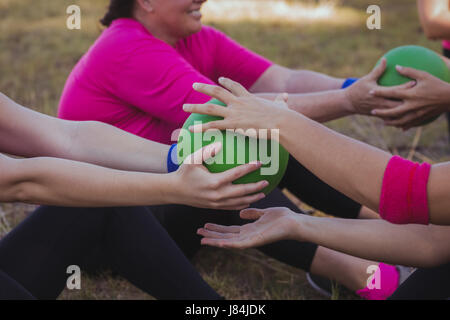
[{"left": 0, "top": 206, "right": 222, "bottom": 299}]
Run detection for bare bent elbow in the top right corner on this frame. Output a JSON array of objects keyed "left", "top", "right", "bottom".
[{"left": 417, "top": 0, "right": 450, "bottom": 40}]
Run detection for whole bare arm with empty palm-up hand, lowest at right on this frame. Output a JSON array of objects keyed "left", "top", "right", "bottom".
[{"left": 198, "top": 208, "right": 450, "bottom": 267}]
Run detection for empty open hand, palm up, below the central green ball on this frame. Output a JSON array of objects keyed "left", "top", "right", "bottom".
[{"left": 197, "top": 208, "right": 299, "bottom": 249}]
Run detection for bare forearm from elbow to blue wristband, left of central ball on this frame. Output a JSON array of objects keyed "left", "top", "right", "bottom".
[{"left": 64, "top": 122, "right": 170, "bottom": 173}]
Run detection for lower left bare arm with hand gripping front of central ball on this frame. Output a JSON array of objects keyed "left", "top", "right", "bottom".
[{"left": 0, "top": 144, "right": 267, "bottom": 209}]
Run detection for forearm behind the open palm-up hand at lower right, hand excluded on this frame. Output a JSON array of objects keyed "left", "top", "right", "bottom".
[{"left": 294, "top": 215, "right": 450, "bottom": 267}]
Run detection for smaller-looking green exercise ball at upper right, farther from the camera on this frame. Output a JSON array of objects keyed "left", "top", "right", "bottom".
[{"left": 377, "top": 45, "right": 450, "bottom": 125}]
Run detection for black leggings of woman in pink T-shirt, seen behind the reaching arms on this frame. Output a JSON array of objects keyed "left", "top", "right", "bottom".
[{"left": 151, "top": 157, "right": 361, "bottom": 271}]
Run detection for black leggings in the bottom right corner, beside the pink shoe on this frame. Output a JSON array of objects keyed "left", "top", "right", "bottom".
[{"left": 389, "top": 263, "right": 450, "bottom": 300}]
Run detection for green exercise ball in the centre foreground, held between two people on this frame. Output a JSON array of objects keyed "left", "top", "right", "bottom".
[{"left": 177, "top": 99, "right": 289, "bottom": 195}]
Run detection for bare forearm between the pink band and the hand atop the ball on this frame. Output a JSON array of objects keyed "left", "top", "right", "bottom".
[{"left": 274, "top": 112, "right": 391, "bottom": 211}]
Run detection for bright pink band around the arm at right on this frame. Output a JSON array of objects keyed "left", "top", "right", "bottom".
[{"left": 380, "top": 156, "right": 431, "bottom": 224}]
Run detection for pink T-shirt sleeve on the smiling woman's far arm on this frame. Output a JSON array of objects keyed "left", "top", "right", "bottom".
[{"left": 210, "top": 28, "right": 273, "bottom": 89}]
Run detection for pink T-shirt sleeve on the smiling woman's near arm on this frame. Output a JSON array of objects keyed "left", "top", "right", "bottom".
[{"left": 110, "top": 43, "right": 213, "bottom": 124}]
